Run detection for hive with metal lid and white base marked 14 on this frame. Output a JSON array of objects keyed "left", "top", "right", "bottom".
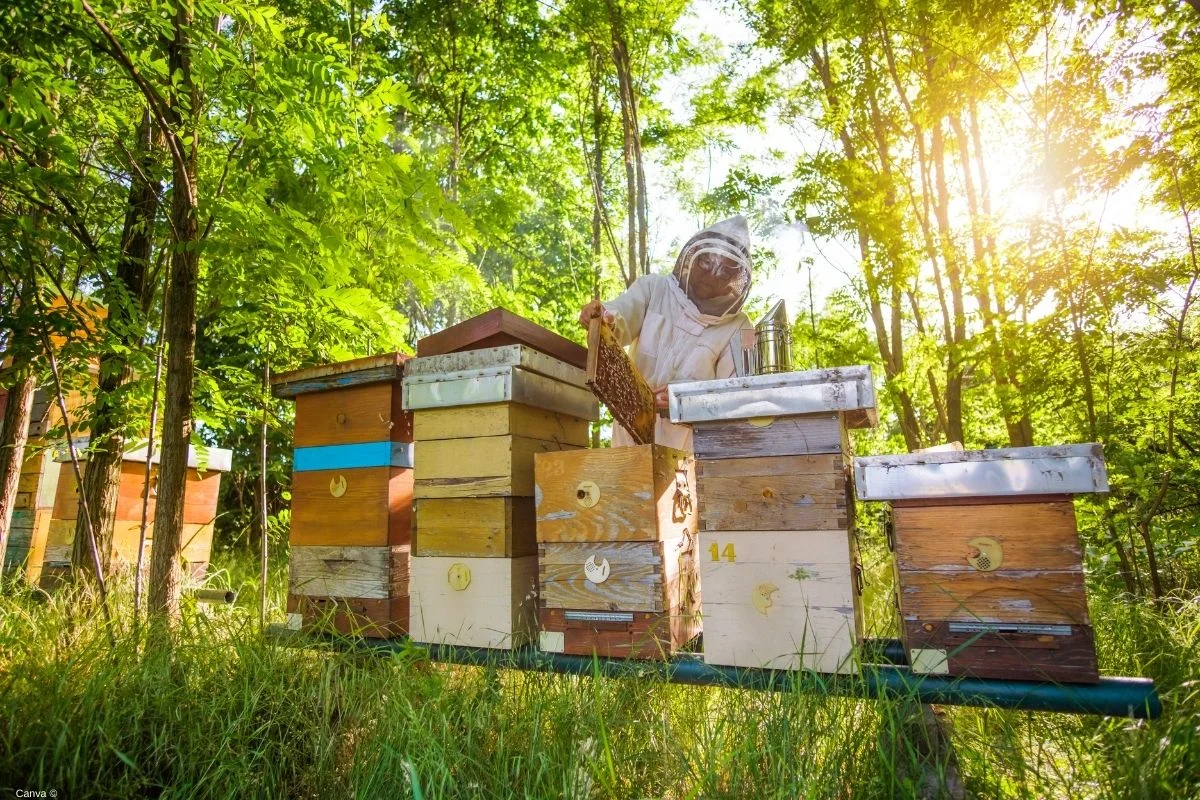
[{"left": 670, "top": 367, "right": 875, "bottom": 673}]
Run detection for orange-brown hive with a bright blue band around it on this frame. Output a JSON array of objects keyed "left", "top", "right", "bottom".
[{"left": 272, "top": 353, "right": 413, "bottom": 637}]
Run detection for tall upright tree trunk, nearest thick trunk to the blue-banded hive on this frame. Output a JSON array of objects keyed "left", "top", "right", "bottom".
[{"left": 149, "top": 0, "right": 200, "bottom": 620}]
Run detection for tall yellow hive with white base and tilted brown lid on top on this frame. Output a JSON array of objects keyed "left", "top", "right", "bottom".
[{"left": 404, "top": 309, "right": 599, "bottom": 649}]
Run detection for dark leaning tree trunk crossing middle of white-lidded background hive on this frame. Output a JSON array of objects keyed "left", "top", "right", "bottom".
[{"left": 71, "top": 109, "right": 160, "bottom": 575}]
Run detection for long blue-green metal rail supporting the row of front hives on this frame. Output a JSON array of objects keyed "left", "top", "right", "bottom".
[{"left": 268, "top": 625, "right": 1163, "bottom": 720}]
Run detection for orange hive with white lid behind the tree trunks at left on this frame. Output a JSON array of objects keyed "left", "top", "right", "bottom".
[{"left": 41, "top": 440, "right": 233, "bottom": 585}]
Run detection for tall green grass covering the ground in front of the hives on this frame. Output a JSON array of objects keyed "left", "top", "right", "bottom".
[{"left": 0, "top": 551, "right": 1200, "bottom": 800}]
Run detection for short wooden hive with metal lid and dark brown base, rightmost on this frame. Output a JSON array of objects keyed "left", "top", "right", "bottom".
[{"left": 854, "top": 444, "right": 1108, "bottom": 682}]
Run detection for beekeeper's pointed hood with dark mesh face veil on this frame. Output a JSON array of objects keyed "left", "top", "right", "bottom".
[{"left": 674, "top": 215, "right": 750, "bottom": 317}]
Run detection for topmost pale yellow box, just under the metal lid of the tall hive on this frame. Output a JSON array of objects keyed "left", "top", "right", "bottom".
[{"left": 413, "top": 403, "right": 592, "bottom": 447}]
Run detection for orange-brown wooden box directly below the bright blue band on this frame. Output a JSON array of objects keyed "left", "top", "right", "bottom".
[{"left": 289, "top": 467, "right": 413, "bottom": 547}]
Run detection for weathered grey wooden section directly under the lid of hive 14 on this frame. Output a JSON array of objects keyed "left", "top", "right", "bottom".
[{"left": 692, "top": 414, "right": 850, "bottom": 459}]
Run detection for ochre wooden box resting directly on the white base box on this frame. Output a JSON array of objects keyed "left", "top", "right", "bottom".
[{"left": 413, "top": 498, "right": 538, "bottom": 558}]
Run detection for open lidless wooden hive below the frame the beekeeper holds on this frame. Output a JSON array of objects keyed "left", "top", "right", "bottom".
[{"left": 535, "top": 445, "right": 700, "bottom": 658}]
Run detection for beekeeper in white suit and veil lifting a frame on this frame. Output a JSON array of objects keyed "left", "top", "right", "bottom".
[{"left": 580, "top": 216, "right": 754, "bottom": 450}]
